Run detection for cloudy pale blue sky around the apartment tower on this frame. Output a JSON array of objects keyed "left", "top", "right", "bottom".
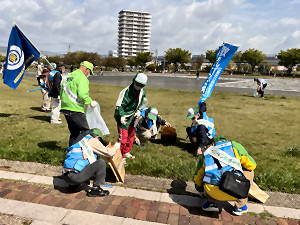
[{"left": 0, "top": 0, "right": 300, "bottom": 55}]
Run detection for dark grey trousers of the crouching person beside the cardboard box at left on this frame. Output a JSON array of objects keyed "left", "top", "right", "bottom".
[{"left": 65, "top": 159, "right": 106, "bottom": 187}]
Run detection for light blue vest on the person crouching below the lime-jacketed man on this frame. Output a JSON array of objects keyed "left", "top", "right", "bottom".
[{"left": 64, "top": 135, "right": 97, "bottom": 173}]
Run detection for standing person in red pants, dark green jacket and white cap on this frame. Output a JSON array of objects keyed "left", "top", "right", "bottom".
[{"left": 114, "top": 73, "right": 148, "bottom": 165}]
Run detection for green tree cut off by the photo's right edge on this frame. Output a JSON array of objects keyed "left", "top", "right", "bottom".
[{"left": 277, "top": 48, "right": 300, "bottom": 75}]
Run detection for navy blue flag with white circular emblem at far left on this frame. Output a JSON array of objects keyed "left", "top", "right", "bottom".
[{"left": 3, "top": 24, "right": 40, "bottom": 90}]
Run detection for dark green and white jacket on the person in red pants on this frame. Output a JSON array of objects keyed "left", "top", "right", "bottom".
[{"left": 114, "top": 83, "right": 146, "bottom": 130}]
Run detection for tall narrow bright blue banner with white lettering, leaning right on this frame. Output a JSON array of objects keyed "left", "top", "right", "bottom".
[{"left": 198, "top": 43, "right": 239, "bottom": 106}]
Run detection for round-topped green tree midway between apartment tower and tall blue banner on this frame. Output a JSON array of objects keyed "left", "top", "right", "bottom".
[{"left": 166, "top": 48, "right": 192, "bottom": 72}]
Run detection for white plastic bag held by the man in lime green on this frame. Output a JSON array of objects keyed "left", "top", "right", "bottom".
[{"left": 86, "top": 103, "right": 109, "bottom": 135}]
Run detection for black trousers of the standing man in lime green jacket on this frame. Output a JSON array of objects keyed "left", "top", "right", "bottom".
[{"left": 61, "top": 110, "right": 90, "bottom": 146}]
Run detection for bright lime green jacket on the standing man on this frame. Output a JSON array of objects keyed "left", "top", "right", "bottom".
[{"left": 60, "top": 69, "right": 92, "bottom": 113}]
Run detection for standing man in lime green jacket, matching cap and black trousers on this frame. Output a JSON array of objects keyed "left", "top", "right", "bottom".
[{"left": 60, "top": 61, "right": 98, "bottom": 146}]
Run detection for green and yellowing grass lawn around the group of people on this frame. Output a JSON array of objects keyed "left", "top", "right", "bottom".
[{"left": 0, "top": 78, "right": 300, "bottom": 193}]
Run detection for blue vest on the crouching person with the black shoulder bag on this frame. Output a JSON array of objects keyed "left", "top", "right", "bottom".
[{"left": 203, "top": 141, "right": 241, "bottom": 186}]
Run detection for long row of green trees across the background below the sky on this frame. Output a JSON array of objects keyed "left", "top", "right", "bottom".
[{"left": 0, "top": 48, "right": 300, "bottom": 74}]
